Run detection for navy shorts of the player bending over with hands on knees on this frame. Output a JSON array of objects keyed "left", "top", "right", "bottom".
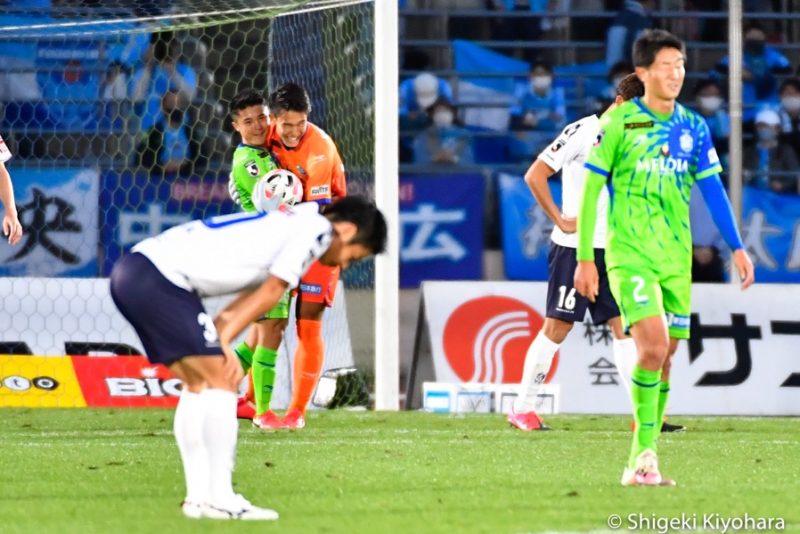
[{"left": 111, "top": 252, "right": 222, "bottom": 366}]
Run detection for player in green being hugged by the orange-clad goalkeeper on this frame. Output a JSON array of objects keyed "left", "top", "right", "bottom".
[{"left": 228, "top": 89, "right": 291, "bottom": 428}]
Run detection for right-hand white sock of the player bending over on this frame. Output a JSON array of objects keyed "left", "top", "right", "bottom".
[{"left": 202, "top": 389, "right": 239, "bottom": 503}]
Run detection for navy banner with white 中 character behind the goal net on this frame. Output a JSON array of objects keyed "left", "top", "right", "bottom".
[{"left": 100, "top": 172, "right": 238, "bottom": 276}]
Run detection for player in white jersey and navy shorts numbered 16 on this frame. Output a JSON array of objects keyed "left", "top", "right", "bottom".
[{"left": 508, "top": 74, "right": 664, "bottom": 431}]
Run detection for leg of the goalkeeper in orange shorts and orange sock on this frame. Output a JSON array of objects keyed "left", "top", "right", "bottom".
[{"left": 283, "top": 262, "right": 339, "bottom": 429}]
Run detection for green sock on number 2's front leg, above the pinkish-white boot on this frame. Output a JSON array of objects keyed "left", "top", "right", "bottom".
[{"left": 628, "top": 364, "right": 661, "bottom": 468}]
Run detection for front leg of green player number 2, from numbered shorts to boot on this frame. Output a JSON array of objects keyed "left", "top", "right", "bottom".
[{"left": 608, "top": 264, "right": 669, "bottom": 485}]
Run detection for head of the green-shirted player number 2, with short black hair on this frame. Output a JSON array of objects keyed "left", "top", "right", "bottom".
[{"left": 633, "top": 30, "right": 686, "bottom": 101}]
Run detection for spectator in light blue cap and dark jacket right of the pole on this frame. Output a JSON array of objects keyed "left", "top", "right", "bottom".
[{"left": 743, "top": 109, "right": 800, "bottom": 194}]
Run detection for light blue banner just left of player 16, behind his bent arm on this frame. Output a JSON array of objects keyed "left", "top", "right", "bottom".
[{"left": 497, "top": 173, "right": 561, "bottom": 280}]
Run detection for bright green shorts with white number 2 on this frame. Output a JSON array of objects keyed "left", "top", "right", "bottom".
[{"left": 608, "top": 265, "right": 692, "bottom": 339}]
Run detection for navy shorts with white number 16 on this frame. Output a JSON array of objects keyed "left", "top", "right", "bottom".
[{"left": 546, "top": 243, "right": 619, "bottom": 324}]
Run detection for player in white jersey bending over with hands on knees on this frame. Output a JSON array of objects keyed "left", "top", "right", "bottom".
[{"left": 111, "top": 196, "right": 386, "bottom": 520}]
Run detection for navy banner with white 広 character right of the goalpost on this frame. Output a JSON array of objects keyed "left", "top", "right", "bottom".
[{"left": 400, "top": 174, "right": 484, "bottom": 288}]
